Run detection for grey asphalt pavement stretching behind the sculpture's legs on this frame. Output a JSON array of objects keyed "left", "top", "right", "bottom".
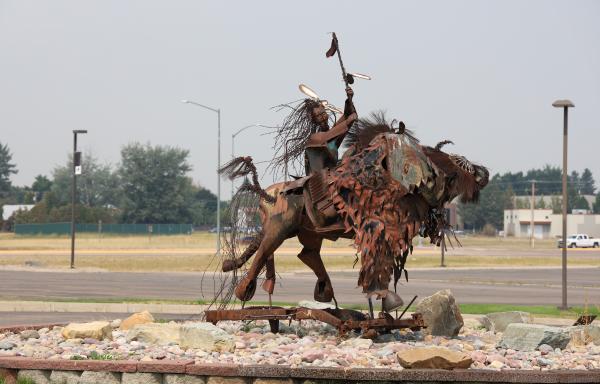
[{"left": 0, "top": 267, "right": 600, "bottom": 324}]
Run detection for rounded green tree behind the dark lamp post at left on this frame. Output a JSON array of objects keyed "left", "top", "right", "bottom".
[{"left": 51, "top": 155, "right": 121, "bottom": 207}]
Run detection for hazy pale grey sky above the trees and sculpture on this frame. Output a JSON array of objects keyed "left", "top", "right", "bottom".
[{"left": 0, "top": 0, "right": 600, "bottom": 200}]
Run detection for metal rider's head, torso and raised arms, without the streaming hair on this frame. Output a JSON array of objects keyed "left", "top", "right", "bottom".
[{"left": 305, "top": 87, "right": 358, "bottom": 175}]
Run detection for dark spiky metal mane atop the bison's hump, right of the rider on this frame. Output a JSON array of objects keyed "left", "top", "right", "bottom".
[{"left": 344, "top": 111, "right": 419, "bottom": 148}]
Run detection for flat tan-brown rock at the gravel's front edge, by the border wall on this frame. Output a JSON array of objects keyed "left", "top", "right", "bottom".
[{"left": 396, "top": 347, "right": 473, "bottom": 369}]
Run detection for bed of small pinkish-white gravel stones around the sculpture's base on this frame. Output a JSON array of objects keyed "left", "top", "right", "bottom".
[{"left": 0, "top": 321, "right": 600, "bottom": 370}]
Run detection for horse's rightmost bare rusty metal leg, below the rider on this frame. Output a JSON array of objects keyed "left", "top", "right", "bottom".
[{"left": 298, "top": 230, "right": 335, "bottom": 303}]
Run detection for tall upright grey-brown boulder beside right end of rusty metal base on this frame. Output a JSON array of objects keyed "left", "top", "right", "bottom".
[{"left": 415, "top": 289, "right": 464, "bottom": 337}]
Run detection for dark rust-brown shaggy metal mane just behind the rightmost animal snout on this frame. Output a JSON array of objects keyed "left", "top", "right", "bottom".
[{"left": 422, "top": 145, "right": 481, "bottom": 203}]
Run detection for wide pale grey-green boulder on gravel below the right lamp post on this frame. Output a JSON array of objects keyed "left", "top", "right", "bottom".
[{"left": 498, "top": 324, "right": 571, "bottom": 351}]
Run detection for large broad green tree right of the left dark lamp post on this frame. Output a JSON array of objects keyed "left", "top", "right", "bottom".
[{"left": 119, "top": 143, "right": 193, "bottom": 223}]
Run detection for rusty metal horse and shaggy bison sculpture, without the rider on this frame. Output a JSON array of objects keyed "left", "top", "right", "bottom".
[{"left": 220, "top": 114, "right": 489, "bottom": 315}]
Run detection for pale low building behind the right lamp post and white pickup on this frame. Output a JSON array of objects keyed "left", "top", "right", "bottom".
[{"left": 504, "top": 209, "right": 600, "bottom": 239}]
